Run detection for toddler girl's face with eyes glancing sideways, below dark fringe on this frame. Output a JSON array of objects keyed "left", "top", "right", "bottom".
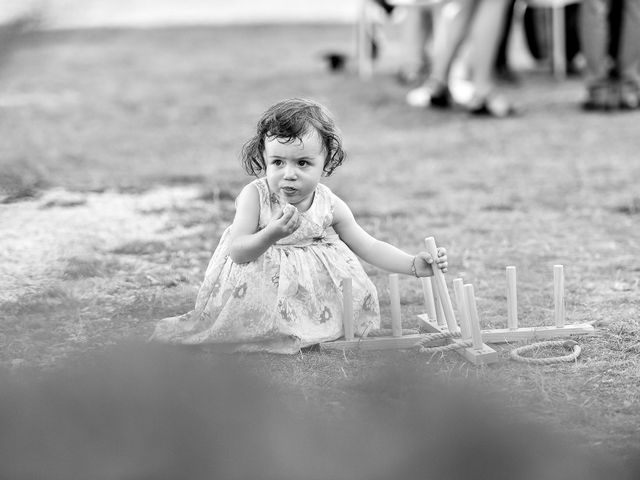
[{"left": 264, "top": 130, "right": 326, "bottom": 212}]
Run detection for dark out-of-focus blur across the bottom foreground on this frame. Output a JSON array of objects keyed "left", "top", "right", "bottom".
[{"left": 0, "top": 344, "right": 637, "bottom": 480}]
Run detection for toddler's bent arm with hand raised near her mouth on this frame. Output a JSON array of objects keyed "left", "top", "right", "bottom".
[{"left": 229, "top": 184, "right": 300, "bottom": 263}]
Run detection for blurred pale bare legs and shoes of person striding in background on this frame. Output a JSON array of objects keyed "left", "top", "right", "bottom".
[{"left": 407, "top": 0, "right": 513, "bottom": 117}]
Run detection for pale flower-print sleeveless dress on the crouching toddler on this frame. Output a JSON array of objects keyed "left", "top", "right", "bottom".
[{"left": 151, "top": 178, "right": 380, "bottom": 353}]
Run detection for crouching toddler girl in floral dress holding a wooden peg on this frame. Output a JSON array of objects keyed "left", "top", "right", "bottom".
[{"left": 152, "top": 99, "right": 447, "bottom": 353}]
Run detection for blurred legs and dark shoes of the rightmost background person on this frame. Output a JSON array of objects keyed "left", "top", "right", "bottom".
[{"left": 580, "top": 0, "right": 640, "bottom": 110}]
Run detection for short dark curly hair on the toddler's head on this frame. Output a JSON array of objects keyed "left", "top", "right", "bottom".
[{"left": 242, "top": 98, "right": 346, "bottom": 176}]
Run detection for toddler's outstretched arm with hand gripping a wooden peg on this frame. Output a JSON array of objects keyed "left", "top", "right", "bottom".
[{"left": 333, "top": 195, "right": 447, "bottom": 277}]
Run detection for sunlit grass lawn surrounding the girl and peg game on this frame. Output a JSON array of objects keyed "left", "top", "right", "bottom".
[{"left": 0, "top": 21, "right": 640, "bottom": 472}]
